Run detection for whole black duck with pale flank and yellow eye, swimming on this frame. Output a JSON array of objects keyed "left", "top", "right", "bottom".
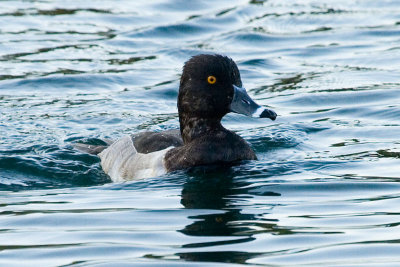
[{"left": 76, "top": 54, "right": 277, "bottom": 182}]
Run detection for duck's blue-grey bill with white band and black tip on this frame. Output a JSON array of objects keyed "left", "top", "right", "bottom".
[{"left": 231, "top": 85, "right": 277, "bottom": 120}]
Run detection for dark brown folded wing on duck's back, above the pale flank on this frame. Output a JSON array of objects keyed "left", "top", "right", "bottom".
[{"left": 132, "top": 130, "right": 183, "bottom": 154}]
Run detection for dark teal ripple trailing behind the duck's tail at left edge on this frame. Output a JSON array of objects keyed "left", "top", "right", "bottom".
[{"left": 0, "top": 146, "right": 109, "bottom": 190}]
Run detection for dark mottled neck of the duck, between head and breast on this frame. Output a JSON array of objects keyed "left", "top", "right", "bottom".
[{"left": 179, "top": 116, "right": 224, "bottom": 144}]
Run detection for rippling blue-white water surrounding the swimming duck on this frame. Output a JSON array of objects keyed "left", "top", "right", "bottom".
[{"left": 0, "top": 0, "right": 400, "bottom": 266}]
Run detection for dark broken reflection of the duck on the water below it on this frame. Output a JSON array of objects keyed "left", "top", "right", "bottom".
[{"left": 177, "top": 166, "right": 279, "bottom": 263}]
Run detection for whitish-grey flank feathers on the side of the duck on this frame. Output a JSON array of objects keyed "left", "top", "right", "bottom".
[{"left": 99, "top": 135, "right": 173, "bottom": 182}]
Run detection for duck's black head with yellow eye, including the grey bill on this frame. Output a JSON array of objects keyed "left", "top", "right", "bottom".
[{"left": 178, "top": 54, "right": 277, "bottom": 120}]
